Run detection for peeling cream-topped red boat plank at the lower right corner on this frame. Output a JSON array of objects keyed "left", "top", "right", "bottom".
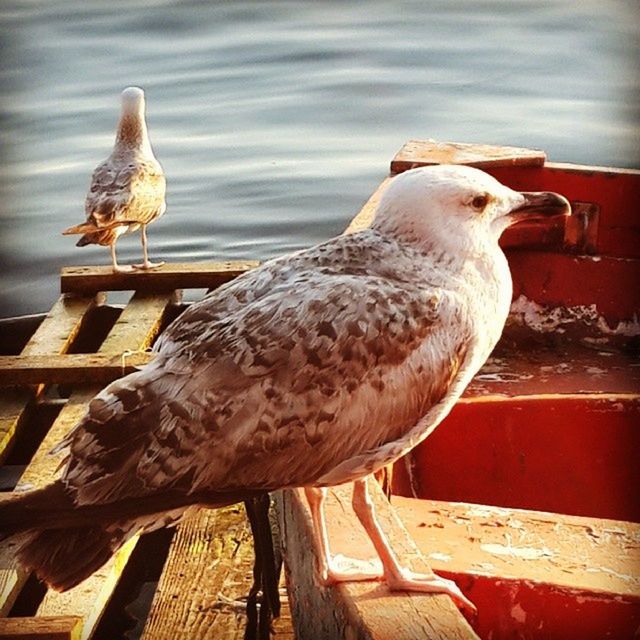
[{"left": 392, "top": 496, "right": 640, "bottom": 640}]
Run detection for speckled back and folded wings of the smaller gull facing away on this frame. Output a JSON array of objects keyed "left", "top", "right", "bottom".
[{"left": 85, "top": 159, "right": 166, "bottom": 229}]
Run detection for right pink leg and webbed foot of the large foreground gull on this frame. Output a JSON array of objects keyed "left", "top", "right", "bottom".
[{"left": 353, "top": 478, "right": 476, "bottom": 612}]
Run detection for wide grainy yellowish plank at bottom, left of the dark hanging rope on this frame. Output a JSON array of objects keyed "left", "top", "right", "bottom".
[{"left": 142, "top": 505, "right": 293, "bottom": 640}]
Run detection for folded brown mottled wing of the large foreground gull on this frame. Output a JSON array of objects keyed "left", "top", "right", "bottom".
[{"left": 65, "top": 262, "right": 466, "bottom": 503}]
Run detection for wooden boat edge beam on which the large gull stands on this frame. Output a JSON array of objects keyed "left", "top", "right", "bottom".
[{"left": 276, "top": 482, "right": 477, "bottom": 640}]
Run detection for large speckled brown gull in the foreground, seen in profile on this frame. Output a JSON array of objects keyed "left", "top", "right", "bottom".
[{"left": 0, "top": 166, "right": 568, "bottom": 606}]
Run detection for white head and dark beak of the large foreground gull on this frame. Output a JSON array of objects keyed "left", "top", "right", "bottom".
[{"left": 373, "top": 165, "right": 569, "bottom": 254}]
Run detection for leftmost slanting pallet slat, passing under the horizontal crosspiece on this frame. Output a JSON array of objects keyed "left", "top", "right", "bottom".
[{"left": 0, "top": 295, "right": 102, "bottom": 462}]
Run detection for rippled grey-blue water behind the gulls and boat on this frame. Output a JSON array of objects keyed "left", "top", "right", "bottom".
[{"left": 0, "top": 0, "right": 640, "bottom": 316}]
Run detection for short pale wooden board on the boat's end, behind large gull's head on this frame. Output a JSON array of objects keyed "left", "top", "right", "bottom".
[{"left": 391, "top": 140, "right": 546, "bottom": 173}]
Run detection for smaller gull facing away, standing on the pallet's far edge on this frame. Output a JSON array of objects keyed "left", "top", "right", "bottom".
[{"left": 62, "top": 87, "right": 166, "bottom": 272}]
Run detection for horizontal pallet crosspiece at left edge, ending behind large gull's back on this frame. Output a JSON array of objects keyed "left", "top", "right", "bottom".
[{"left": 0, "top": 351, "right": 153, "bottom": 387}]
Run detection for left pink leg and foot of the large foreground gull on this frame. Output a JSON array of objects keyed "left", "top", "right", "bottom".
[{"left": 304, "top": 487, "right": 382, "bottom": 584}]
